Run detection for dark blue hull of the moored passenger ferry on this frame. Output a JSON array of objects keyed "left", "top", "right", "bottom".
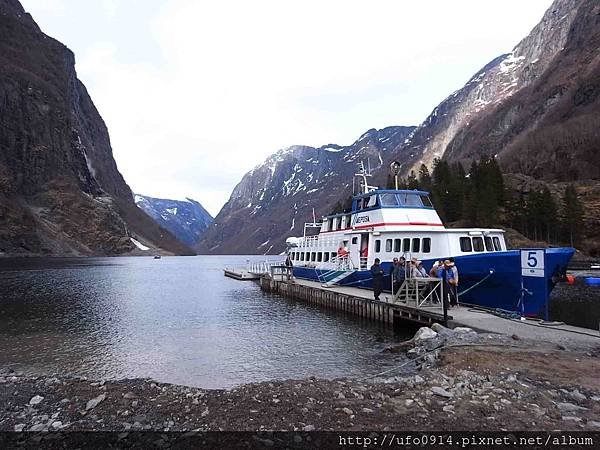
[{"left": 294, "top": 248, "right": 575, "bottom": 317}]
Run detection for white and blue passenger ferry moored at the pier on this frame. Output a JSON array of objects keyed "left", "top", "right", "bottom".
[{"left": 286, "top": 165, "right": 574, "bottom": 316}]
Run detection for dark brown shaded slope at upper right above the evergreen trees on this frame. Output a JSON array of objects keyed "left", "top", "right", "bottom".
[{"left": 446, "top": 0, "right": 600, "bottom": 182}]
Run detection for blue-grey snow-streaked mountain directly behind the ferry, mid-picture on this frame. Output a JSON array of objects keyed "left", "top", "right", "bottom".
[{"left": 196, "top": 127, "right": 414, "bottom": 254}]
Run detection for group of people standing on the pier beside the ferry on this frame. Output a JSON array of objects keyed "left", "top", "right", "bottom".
[{"left": 371, "top": 256, "right": 458, "bottom": 307}]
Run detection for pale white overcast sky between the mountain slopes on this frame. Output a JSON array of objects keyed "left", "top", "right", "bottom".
[{"left": 21, "top": 0, "right": 552, "bottom": 215}]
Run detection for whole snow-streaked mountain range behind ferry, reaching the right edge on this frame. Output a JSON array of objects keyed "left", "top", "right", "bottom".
[{"left": 200, "top": 0, "right": 600, "bottom": 253}]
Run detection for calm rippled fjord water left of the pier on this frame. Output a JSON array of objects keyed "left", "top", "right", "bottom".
[{"left": 0, "top": 256, "right": 414, "bottom": 388}]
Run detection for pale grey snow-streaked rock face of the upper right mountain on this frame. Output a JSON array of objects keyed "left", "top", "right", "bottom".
[{"left": 384, "top": 0, "right": 584, "bottom": 179}]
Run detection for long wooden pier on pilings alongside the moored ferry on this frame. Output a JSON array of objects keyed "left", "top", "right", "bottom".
[{"left": 260, "top": 275, "right": 452, "bottom": 326}]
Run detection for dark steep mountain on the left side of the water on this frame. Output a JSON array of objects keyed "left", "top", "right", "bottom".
[{"left": 0, "top": 0, "right": 193, "bottom": 255}]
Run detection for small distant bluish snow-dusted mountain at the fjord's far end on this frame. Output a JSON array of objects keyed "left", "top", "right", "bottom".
[{"left": 135, "top": 194, "right": 214, "bottom": 246}]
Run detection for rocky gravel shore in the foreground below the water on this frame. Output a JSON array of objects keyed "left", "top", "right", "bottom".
[{"left": 0, "top": 327, "right": 600, "bottom": 432}]
